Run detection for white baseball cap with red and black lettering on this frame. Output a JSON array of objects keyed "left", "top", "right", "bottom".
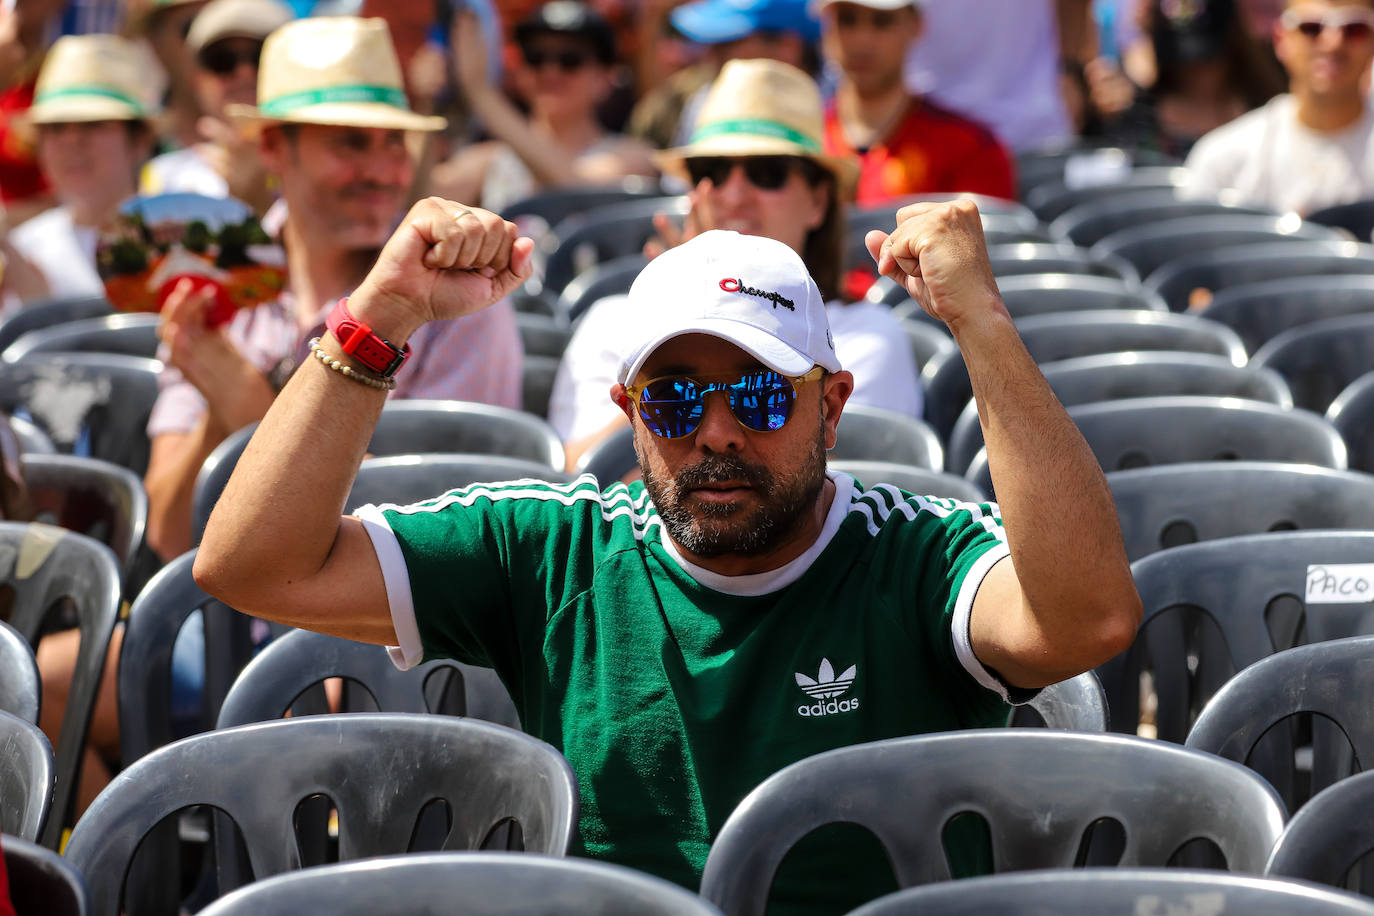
[{"left": 620, "top": 229, "right": 842, "bottom": 385}]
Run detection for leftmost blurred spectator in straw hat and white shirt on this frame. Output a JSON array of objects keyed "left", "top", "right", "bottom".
[{"left": 8, "top": 34, "right": 157, "bottom": 297}]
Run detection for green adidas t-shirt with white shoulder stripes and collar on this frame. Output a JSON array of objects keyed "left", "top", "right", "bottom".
[{"left": 357, "top": 474, "right": 1010, "bottom": 909}]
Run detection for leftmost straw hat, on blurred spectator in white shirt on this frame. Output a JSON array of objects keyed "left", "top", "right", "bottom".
[{"left": 22, "top": 34, "right": 158, "bottom": 125}]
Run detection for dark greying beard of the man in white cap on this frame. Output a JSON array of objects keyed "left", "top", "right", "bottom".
[{"left": 640, "top": 425, "right": 826, "bottom": 558}]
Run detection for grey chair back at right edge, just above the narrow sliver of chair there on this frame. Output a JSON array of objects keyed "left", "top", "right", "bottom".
[{"left": 1250, "top": 312, "right": 1374, "bottom": 411}]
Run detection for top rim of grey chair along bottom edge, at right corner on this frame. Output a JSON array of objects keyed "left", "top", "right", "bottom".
[{"left": 849, "top": 868, "right": 1374, "bottom": 916}]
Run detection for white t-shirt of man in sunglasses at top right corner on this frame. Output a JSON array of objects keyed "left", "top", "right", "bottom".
[{"left": 1184, "top": 95, "right": 1374, "bottom": 214}]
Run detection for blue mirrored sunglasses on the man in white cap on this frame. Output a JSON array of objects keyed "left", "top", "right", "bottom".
[{"left": 625, "top": 365, "right": 824, "bottom": 439}]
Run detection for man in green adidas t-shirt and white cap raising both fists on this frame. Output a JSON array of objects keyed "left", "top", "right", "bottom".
[{"left": 195, "top": 199, "right": 1140, "bottom": 913}]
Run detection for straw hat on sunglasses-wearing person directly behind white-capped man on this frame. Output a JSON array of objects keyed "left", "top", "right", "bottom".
[{"left": 654, "top": 60, "right": 859, "bottom": 196}]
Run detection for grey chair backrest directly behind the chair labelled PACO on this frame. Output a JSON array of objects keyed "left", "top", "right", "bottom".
[{"left": 1107, "top": 461, "right": 1374, "bottom": 560}]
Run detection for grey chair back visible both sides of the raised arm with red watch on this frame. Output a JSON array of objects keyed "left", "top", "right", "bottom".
[{"left": 191, "top": 400, "right": 565, "bottom": 544}]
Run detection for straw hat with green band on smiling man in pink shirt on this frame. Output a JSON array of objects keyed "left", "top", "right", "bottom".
[{"left": 225, "top": 16, "right": 447, "bottom": 130}]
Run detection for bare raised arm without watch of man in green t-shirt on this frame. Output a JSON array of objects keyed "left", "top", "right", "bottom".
[{"left": 867, "top": 201, "right": 1140, "bottom": 688}]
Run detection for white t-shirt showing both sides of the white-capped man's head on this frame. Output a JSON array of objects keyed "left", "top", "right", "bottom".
[{"left": 548, "top": 295, "right": 922, "bottom": 442}]
